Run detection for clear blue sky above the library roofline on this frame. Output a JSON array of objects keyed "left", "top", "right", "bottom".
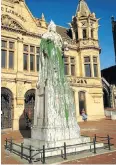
[{"left": 25, "top": 0, "right": 116, "bottom": 69}]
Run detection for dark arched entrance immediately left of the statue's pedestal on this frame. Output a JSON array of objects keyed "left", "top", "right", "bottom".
[{"left": 24, "top": 89, "right": 35, "bottom": 124}]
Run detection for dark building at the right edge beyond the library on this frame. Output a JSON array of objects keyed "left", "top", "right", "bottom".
[{"left": 101, "top": 17, "right": 116, "bottom": 108}]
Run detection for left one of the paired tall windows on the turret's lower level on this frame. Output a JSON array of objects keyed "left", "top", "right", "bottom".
[{"left": 84, "top": 57, "right": 91, "bottom": 77}]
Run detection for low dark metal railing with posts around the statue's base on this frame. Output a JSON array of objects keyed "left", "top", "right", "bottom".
[{"left": 5, "top": 134, "right": 113, "bottom": 164}]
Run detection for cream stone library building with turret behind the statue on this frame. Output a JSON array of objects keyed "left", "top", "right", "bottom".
[{"left": 1, "top": 0, "right": 104, "bottom": 130}]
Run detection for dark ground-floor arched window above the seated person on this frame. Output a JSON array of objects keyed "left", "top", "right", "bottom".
[{"left": 79, "top": 91, "right": 86, "bottom": 115}]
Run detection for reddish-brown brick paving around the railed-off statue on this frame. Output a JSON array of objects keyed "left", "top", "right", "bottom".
[{"left": 1, "top": 119, "right": 116, "bottom": 164}]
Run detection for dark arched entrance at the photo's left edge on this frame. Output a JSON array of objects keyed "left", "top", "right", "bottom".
[{"left": 1, "top": 87, "right": 13, "bottom": 129}]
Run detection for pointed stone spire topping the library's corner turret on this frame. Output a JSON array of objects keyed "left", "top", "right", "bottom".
[{"left": 76, "top": 0, "right": 91, "bottom": 16}]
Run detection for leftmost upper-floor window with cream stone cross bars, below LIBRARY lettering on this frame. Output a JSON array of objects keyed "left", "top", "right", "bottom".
[{"left": 1, "top": 40, "right": 15, "bottom": 69}]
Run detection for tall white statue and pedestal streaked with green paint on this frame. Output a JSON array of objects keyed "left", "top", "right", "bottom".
[{"left": 31, "top": 21, "right": 80, "bottom": 148}]
